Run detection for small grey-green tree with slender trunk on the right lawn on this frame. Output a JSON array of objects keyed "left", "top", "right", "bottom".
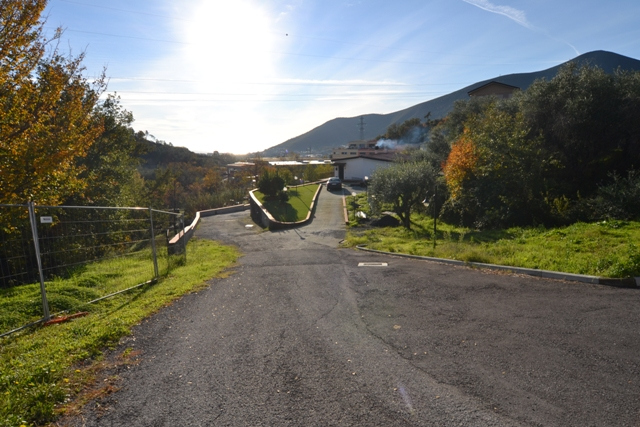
[{"left": 369, "top": 161, "right": 437, "bottom": 230}]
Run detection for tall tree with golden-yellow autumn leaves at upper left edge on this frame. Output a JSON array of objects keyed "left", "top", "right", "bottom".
[{"left": 0, "top": 0, "right": 105, "bottom": 204}]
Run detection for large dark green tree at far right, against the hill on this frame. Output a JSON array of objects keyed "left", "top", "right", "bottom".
[{"left": 514, "top": 63, "right": 640, "bottom": 199}]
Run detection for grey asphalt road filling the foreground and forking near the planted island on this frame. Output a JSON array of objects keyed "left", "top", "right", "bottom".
[{"left": 65, "top": 190, "right": 640, "bottom": 426}]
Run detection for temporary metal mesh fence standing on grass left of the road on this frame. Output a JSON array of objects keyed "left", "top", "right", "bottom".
[{"left": 0, "top": 203, "right": 186, "bottom": 337}]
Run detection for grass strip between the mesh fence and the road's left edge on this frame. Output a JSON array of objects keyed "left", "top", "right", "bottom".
[{"left": 0, "top": 239, "right": 239, "bottom": 427}]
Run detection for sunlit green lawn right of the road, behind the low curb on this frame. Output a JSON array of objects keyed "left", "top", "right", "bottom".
[{"left": 346, "top": 193, "right": 640, "bottom": 278}]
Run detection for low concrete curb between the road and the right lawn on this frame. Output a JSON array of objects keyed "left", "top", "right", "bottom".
[{"left": 356, "top": 245, "right": 640, "bottom": 289}]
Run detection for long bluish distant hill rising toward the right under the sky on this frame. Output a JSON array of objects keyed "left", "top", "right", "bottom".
[{"left": 262, "top": 50, "right": 640, "bottom": 156}]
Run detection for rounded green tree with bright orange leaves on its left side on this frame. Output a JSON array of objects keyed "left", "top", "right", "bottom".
[{"left": 443, "top": 102, "right": 550, "bottom": 228}]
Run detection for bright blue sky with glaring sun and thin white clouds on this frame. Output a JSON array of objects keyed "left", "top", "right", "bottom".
[{"left": 45, "top": 0, "right": 640, "bottom": 154}]
